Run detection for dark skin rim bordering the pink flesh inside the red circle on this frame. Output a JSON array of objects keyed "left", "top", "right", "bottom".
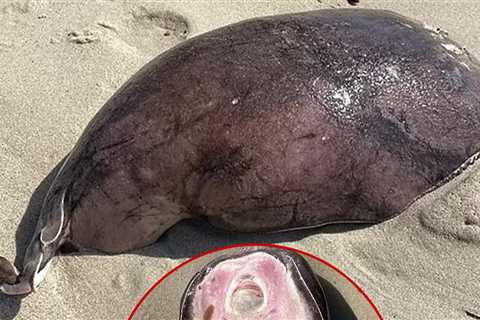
[{"left": 179, "top": 248, "right": 330, "bottom": 320}]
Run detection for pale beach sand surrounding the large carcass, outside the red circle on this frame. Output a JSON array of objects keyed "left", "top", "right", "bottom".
[{"left": 0, "top": 0, "right": 480, "bottom": 320}]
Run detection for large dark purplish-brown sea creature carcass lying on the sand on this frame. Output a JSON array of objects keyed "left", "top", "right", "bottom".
[{"left": 0, "top": 10, "right": 480, "bottom": 294}]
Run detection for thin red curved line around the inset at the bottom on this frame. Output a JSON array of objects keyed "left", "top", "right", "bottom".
[{"left": 128, "top": 243, "right": 384, "bottom": 320}]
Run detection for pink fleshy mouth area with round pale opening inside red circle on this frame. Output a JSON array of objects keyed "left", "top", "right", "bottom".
[{"left": 188, "top": 252, "right": 313, "bottom": 320}]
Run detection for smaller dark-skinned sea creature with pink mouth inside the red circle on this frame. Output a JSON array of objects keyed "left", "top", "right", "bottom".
[{"left": 180, "top": 249, "right": 329, "bottom": 320}]
